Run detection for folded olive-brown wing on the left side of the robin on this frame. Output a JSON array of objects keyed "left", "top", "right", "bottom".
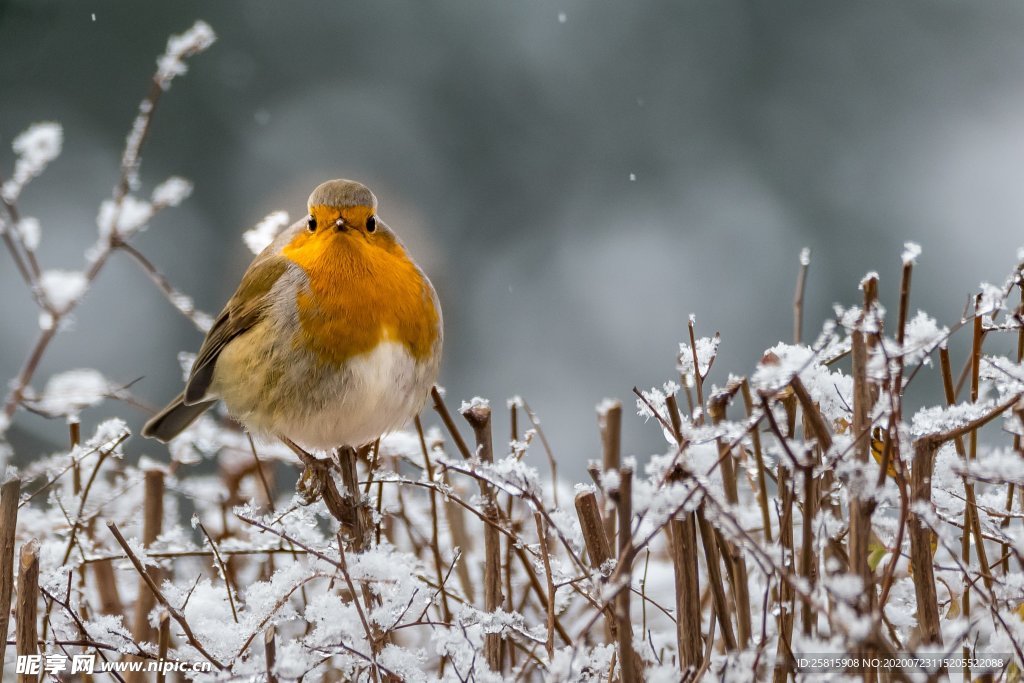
[{"left": 184, "top": 255, "right": 290, "bottom": 405}]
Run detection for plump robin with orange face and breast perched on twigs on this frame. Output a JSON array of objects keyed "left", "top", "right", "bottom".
[{"left": 142, "top": 180, "right": 442, "bottom": 450}]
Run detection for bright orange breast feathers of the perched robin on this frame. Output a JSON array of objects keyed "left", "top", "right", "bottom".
[{"left": 282, "top": 230, "right": 440, "bottom": 366}]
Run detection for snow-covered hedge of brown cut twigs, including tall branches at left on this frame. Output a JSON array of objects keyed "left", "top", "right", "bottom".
[{"left": 0, "top": 18, "right": 1024, "bottom": 682}]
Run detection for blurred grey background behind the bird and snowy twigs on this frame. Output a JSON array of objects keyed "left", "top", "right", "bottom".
[{"left": 0, "top": 0, "right": 1024, "bottom": 476}]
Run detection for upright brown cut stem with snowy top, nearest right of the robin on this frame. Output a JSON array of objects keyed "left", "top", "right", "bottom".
[{"left": 462, "top": 401, "right": 502, "bottom": 672}]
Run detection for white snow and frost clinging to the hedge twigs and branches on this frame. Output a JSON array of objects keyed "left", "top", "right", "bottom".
[{"left": 8, "top": 82, "right": 1024, "bottom": 682}]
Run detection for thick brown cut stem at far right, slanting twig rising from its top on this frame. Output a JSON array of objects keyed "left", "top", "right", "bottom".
[{"left": 909, "top": 436, "right": 937, "bottom": 645}]
